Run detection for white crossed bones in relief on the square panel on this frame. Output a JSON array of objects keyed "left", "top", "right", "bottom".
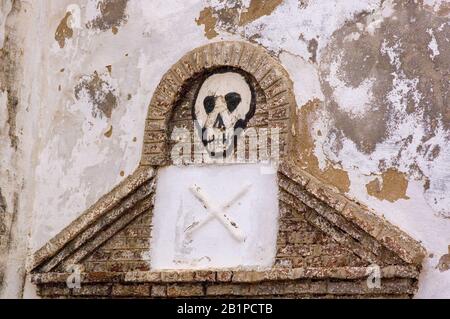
[{"left": 185, "top": 184, "right": 251, "bottom": 242}]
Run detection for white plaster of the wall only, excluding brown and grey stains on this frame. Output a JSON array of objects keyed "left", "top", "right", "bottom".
[{"left": 0, "top": 0, "right": 450, "bottom": 298}]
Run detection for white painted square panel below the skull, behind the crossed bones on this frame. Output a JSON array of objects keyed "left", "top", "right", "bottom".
[{"left": 151, "top": 164, "right": 278, "bottom": 270}]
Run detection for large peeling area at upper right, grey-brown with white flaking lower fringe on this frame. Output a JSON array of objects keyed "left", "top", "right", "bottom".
[{"left": 316, "top": 1, "right": 450, "bottom": 216}]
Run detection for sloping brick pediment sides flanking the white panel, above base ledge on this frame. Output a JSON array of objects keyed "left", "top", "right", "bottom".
[{"left": 32, "top": 162, "right": 424, "bottom": 295}]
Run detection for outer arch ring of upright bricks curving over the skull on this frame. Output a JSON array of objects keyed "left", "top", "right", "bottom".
[{"left": 140, "top": 41, "right": 296, "bottom": 166}]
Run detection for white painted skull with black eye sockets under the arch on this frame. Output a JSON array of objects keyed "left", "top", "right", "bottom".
[{"left": 193, "top": 72, "right": 255, "bottom": 156}]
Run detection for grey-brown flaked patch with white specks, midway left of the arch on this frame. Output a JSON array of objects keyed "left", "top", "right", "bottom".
[{"left": 75, "top": 71, "right": 118, "bottom": 118}]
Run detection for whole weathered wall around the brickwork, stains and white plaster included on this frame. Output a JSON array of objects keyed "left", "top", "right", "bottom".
[{"left": 0, "top": 0, "right": 450, "bottom": 298}]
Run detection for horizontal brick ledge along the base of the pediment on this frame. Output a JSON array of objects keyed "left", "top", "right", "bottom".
[{"left": 33, "top": 266, "right": 419, "bottom": 298}]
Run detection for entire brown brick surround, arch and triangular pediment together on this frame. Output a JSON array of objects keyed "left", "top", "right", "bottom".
[{"left": 30, "top": 42, "right": 425, "bottom": 298}]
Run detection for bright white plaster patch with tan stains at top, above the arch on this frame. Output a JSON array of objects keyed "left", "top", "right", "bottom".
[{"left": 197, "top": 0, "right": 382, "bottom": 62}]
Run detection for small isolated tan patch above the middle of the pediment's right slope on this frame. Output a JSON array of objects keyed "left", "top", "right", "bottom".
[{"left": 366, "top": 168, "right": 409, "bottom": 203}]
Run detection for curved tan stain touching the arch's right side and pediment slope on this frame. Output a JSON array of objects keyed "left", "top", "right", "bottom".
[{"left": 295, "top": 100, "right": 350, "bottom": 193}]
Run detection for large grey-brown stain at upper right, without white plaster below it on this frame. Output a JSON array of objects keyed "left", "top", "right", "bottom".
[{"left": 321, "top": 1, "right": 450, "bottom": 154}]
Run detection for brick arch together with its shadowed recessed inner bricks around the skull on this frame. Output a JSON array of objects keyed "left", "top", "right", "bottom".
[{"left": 140, "top": 42, "right": 296, "bottom": 166}]
